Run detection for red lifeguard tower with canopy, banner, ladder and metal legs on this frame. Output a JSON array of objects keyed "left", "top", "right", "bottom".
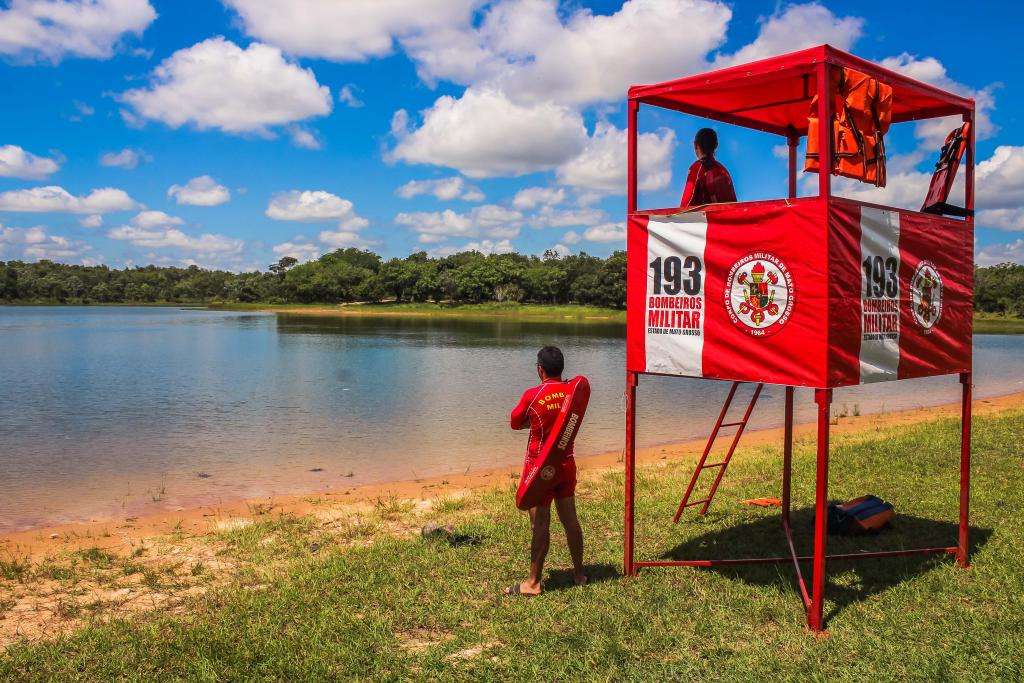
[{"left": 625, "top": 45, "right": 975, "bottom": 632}]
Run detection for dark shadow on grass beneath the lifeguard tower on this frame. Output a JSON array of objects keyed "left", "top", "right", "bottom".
[{"left": 662, "top": 507, "right": 992, "bottom": 618}]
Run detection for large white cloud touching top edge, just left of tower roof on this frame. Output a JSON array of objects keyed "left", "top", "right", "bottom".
[{"left": 402, "top": 0, "right": 731, "bottom": 105}]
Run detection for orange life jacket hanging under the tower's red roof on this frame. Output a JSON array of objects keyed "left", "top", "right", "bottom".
[{"left": 804, "top": 69, "right": 893, "bottom": 187}]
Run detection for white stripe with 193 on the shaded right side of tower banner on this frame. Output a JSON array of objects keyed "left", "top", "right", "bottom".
[{"left": 860, "top": 207, "right": 899, "bottom": 384}]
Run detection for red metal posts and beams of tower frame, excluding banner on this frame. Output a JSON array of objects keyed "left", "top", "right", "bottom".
[{"left": 623, "top": 48, "right": 975, "bottom": 633}]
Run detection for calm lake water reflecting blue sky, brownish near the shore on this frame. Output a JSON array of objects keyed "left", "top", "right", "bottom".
[{"left": 0, "top": 307, "right": 1024, "bottom": 530}]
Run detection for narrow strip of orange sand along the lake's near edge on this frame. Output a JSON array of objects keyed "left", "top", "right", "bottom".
[{"left": 6, "top": 392, "right": 1024, "bottom": 558}]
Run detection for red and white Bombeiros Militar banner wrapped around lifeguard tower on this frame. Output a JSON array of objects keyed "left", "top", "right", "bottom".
[{"left": 627, "top": 198, "right": 973, "bottom": 387}]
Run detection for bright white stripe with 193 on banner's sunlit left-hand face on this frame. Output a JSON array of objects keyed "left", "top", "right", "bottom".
[{"left": 644, "top": 212, "right": 708, "bottom": 377}]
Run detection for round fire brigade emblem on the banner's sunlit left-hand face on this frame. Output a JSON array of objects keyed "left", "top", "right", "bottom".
[{"left": 725, "top": 252, "right": 794, "bottom": 337}]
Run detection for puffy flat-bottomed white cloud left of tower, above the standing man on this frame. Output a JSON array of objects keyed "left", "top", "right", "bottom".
[{"left": 390, "top": 88, "right": 587, "bottom": 178}]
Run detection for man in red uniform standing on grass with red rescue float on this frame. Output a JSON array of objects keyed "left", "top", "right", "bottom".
[{"left": 505, "top": 346, "right": 590, "bottom": 596}]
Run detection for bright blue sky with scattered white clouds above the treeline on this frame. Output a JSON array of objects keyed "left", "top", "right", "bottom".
[{"left": 0, "top": 0, "right": 1024, "bottom": 270}]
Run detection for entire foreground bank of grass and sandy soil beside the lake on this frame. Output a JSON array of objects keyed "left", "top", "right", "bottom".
[{"left": 0, "top": 394, "right": 1024, "bottom": 680}]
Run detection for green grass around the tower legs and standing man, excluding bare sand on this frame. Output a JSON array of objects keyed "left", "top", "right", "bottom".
[{"left": 0, "top": 411, "right": 1024, "bottom": 681}]
